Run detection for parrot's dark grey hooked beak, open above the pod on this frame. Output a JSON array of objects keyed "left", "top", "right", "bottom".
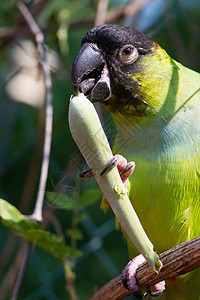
[{"left": 71, "top": 43, "right": 111, "bottom": 102}]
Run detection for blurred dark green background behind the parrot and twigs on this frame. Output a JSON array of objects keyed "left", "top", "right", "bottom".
[{"left": 0, "top": 0, "right": 200, "bottom": 300}]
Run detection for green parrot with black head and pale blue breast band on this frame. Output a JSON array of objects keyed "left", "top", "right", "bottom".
[{"left": 72, "top": 24, "right": 200, "bottom": 300}]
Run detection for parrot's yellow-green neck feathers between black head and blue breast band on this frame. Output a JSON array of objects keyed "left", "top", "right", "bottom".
[{"left": 105, "top": 44, "right": 200, "bottom": 125}]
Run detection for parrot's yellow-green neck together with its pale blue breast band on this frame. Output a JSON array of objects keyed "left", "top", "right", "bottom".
[{"left": 109, "top": 46, "right": 200, "bottom": 160}]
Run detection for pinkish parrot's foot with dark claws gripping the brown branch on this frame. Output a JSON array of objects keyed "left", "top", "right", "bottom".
[{"left": 122, "top": 254, "right": 165, "bottom": 299}]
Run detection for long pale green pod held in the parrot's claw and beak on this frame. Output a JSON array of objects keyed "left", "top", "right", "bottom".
[{"left": 69, "top": 94, "right": 162, "bottom": 271}]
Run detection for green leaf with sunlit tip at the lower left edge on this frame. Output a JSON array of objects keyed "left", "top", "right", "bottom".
[{"left": 0, "top": 199, "right": 81, "bottom": 263}]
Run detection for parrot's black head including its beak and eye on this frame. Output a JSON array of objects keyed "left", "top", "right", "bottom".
[{"left": 72, "top": 24, "right": 155, "bottom": 113}]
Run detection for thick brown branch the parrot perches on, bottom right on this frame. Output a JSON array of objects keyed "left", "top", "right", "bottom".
[{"left": 88, "top": 237, "right": 200, "bottom": 300}]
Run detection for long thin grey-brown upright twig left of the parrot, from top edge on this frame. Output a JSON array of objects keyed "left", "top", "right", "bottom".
[{"left": 16, "top": 1, "right": 53, "bottom": 222}]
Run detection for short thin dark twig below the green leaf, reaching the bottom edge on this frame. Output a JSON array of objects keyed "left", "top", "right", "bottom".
[{"left": 11, "top": 242, "right": 32, "bottom": 300}]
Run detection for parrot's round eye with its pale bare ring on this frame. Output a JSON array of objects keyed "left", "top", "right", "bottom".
[{"left": 117, "top": 45, "right": 138, "bottom": 65}]
